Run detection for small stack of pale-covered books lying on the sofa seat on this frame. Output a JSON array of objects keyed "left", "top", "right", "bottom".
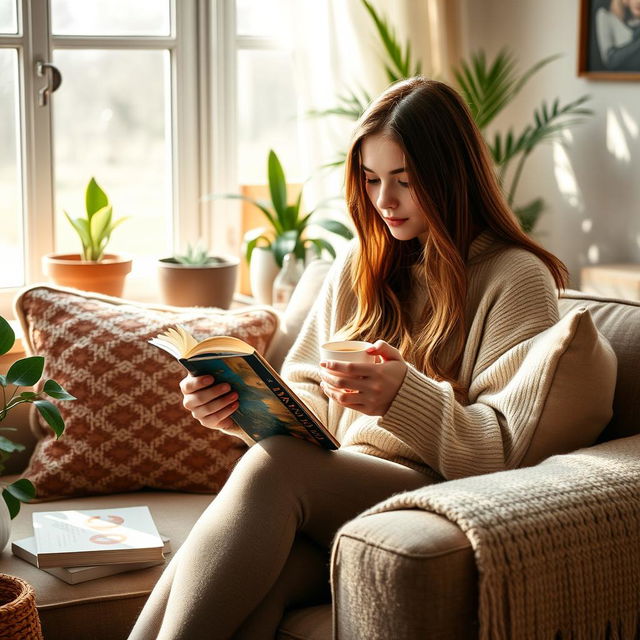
[{"left": 11, "top": 506, "right": 171, "bottom": 584}]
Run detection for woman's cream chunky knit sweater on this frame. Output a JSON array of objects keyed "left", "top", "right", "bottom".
[{"left": 282, "top": 233, "right": 559, "bottom": 481}]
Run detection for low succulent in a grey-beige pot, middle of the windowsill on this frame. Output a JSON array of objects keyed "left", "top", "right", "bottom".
[{"left": 158, "top": 245, "right": 240, "bottom": 309}]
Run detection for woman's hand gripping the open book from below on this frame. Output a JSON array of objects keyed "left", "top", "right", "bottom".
[{"left": 180, "top": 375, "right": 253, "bottom": 444}]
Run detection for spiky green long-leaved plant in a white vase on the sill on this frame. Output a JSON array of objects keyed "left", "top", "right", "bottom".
[{"left": 224, "top": 150, "right": 353, "bottom": 304}]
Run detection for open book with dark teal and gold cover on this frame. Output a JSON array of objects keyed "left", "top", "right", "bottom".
[{"left": 149, "top": 326, "right": 339, "bottom": 449}]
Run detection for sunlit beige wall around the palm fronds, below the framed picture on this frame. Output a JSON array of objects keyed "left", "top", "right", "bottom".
[{"left": 461, "top": 0, "right": 640, "bottom": 286}]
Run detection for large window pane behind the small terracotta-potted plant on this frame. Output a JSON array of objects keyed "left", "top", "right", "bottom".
[{"left": 53, "top": 49, "right": 172, "bottom": 256}]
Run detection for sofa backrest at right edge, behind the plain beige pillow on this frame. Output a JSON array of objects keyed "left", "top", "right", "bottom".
[{"left": 560, "top": 290, "right": 640, "bottom": 441}]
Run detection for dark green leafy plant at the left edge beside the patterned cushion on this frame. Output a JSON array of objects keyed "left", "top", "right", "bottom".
[{"left": 0, "top": 316, "right": 75, "bottom": 519}]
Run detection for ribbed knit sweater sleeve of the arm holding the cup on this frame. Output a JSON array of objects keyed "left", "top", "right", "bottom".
[{"left": 343, "top": 254, "right": 558, "bottom": 479}]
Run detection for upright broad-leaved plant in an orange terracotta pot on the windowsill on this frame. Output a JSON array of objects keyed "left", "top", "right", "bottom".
[{"left": 43, "top": 178, "right": 131, "bottom": 296}]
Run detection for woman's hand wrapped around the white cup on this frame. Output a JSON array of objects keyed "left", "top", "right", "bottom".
[{"left": 320, "top": 340, "right": 407, "bottom": 416}]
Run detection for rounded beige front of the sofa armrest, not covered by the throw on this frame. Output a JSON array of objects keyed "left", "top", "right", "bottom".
[{"left": 331, "top": 510, "right": 478, "bottom": 640}]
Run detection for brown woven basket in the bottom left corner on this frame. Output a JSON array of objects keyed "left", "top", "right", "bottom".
[{"left": 0, "top": 573, "right": 42, "bottom": 640}]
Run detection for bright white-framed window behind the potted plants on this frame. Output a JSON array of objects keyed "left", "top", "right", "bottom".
[{"left": 0, "top": 0, "right": 309, "bottom": 315}]
